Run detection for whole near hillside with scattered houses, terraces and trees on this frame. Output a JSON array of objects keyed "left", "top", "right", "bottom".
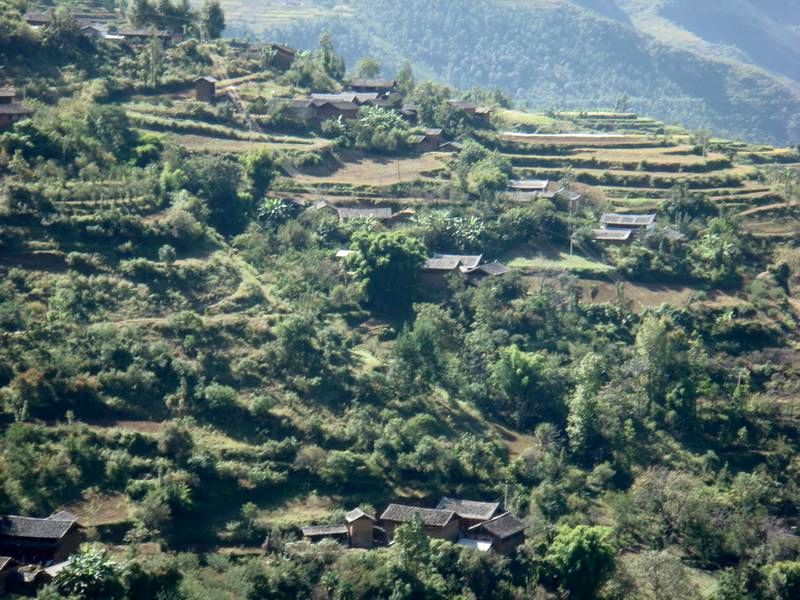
[{"left": 0, "top": 2, "right": 800, "bottom": 600}]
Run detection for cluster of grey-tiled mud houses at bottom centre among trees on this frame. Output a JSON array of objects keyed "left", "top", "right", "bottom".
[{"left": 302, "top": 497, "right": 526, "bottom": 554}]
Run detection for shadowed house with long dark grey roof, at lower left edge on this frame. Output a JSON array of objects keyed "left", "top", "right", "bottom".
[{"left": 0, "top": 512, "right": 83, "bottom": 564}]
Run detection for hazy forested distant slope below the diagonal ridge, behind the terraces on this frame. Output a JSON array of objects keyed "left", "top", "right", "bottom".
[{"left": 232, "top": 0, "right": 800, "bottom": 143}]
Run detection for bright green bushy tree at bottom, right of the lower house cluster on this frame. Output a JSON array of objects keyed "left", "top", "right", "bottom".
[{"left": 544, "top": 525, "right": 615, "bottom": 600}]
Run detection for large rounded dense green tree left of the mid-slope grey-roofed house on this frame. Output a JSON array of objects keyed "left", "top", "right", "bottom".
[{"left": 348, "top": 231, "right": 425, "bottom": 312}]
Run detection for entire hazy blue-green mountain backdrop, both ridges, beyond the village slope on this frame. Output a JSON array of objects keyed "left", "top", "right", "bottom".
[{"left": 234, "top": 0, "right": 800, "bottom": 143}]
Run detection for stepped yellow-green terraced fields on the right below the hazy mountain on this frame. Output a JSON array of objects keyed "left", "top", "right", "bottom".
[{"left": 497, "top": 123, "right": 800, "bottom": 224}]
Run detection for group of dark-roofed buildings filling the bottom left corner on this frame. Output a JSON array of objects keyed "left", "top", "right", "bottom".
[{"left": 0, "top": 511, "right": 83, "bottom": 596}]
